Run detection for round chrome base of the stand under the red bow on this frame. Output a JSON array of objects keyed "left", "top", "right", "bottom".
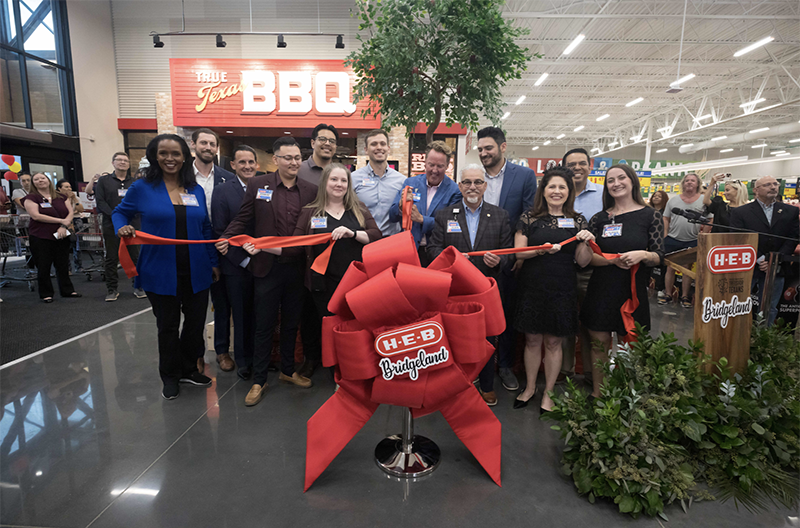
[{"left": 375, "top": 435, "right": 442, "bottom": 478}]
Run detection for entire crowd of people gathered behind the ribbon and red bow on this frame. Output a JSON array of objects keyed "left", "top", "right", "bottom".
[{"left": 11, "top": 124, "right": 800, "bottom": 413}]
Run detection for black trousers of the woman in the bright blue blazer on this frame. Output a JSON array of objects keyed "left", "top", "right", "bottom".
[{"left": 147, "top": 275, "right": 208, "bottom": 385}]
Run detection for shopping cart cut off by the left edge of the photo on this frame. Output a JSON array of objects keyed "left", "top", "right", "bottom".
[{"left": 0, "top": 214, "right": 36, "bottom": 291}]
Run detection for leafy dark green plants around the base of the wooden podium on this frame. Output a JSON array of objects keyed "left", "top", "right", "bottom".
[{"left": 548, "top": 326, "right": 800, "bottom": 518}]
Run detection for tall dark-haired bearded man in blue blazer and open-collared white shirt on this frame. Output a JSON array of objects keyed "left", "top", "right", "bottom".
[{"left": 478, "top": 127, "right": 536, "bottom": 391}]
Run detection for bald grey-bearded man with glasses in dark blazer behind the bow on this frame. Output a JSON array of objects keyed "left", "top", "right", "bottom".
[{"left": 428, "top": 165, "right": 512, "bottom": 406}]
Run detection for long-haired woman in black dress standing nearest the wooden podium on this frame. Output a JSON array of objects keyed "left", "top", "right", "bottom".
[{"left": 581, "top": 165, "right": 664, "bottom": 397}]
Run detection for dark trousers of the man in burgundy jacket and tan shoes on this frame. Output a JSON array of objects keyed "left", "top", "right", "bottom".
[{"left": 253, "top": 261, "right": 305, "bottom": 385}]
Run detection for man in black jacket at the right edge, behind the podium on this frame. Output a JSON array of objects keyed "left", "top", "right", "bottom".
[{"left": 731, "top": 176, "right": 800, "bottom": 325}]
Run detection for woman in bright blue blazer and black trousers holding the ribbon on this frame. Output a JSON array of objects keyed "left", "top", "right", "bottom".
[{"left": 112, "top": 134, "right": 219, "bottom": 400}]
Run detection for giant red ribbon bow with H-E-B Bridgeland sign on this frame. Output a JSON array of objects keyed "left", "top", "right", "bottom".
[{"left": 304, "top": 231, "right": 505, "bottom": 490}]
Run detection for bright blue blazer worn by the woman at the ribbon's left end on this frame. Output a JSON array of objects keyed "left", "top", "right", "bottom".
[{"left": 111, "top": 180, "right": 218, "bottom": 295}]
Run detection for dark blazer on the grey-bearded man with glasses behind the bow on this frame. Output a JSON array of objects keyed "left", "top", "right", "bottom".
[{"left": 428, "top": 201, "right": 513, "bottom": 277}]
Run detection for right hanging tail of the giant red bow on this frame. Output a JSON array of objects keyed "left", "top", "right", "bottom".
[{"left": 439, "top": 387, "right": 502, "bottom": 486}]
